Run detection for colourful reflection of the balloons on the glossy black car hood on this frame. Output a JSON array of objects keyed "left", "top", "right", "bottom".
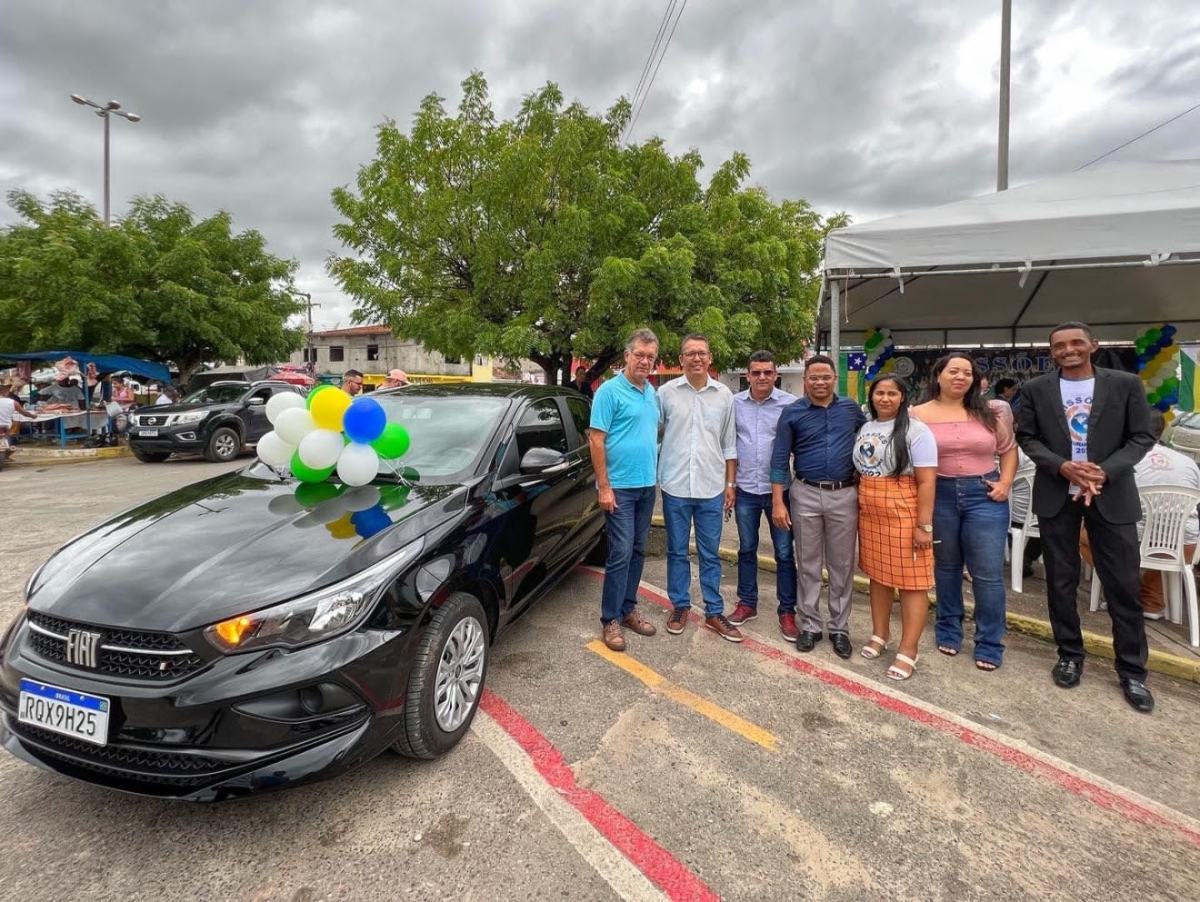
[{"left": 266, "top": 482, "right": 412, "bottom": 539}]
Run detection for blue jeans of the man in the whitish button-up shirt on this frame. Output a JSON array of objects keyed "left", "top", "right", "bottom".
[{"left": 662, "top": 492, "right": 725, "bottom": 617}]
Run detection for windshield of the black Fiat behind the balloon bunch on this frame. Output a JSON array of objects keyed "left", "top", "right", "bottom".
[{"left": 377, "top": 392, "right": 509, "bottom": 481}]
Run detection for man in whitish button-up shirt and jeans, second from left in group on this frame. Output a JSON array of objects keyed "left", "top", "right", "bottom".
[{"left": 659, "top": 335, "right": 743, "bottom": 642}]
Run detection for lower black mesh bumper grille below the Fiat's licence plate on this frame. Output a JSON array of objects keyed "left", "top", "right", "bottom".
[{"left": 8, "top": 717, "right": 227, "bottom": 788}]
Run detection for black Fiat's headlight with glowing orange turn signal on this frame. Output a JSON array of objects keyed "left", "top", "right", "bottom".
[{"left": 204, "top": 539, "right": 425, "bottom": 655}]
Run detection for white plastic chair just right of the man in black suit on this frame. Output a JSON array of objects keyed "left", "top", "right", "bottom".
[{"left": 1090, "top": 486, "right": 1200, "bottom": 648}]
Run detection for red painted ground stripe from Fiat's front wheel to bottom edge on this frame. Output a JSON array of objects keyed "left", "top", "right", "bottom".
[{"left": 479, "top": 688, "right": 720, "bottom": 902}]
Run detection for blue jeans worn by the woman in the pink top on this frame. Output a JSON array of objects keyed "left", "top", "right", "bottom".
[{"left": 934, "top": 473, "right": 1008, "bottom": 666}]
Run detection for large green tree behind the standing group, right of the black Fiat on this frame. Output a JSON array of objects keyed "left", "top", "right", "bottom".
[{"left": 328, "top": 72, "right": 840, "bottom": 383}]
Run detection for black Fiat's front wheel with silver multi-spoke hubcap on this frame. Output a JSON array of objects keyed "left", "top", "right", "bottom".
[{"left": 391, "top": 593, "right": 488, "bottom": 759}]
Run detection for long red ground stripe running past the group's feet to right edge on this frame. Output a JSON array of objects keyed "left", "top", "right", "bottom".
[{"left": 578, "top": 567, "right": 1200, "bottom": 846}]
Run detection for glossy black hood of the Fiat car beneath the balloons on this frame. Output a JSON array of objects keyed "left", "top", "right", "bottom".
[{"left": 29, "top": 467, "right": 467, "bottom": 632}]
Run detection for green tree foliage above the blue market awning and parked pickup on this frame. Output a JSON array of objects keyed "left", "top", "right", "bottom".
[{"left": 0, "top": 191, "right": 302, "bottom": 380}]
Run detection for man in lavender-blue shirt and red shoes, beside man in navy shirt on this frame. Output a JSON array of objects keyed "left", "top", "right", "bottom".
[{"left": 730, "top": 350, "right": 799, "bottom": 642}]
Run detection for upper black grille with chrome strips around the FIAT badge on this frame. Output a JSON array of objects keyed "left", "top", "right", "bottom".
[{"left": 26, "top": 611, "right": 204, "bottom": 682}]
